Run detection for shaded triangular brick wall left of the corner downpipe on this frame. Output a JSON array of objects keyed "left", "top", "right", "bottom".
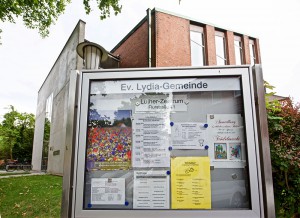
[{"left": 114, "top": 20, "right": 148, "bottom": 68}]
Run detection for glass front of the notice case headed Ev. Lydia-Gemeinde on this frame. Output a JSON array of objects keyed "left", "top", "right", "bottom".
[{"left": 83, "top": 77, "right": 251, "bottom": 210}]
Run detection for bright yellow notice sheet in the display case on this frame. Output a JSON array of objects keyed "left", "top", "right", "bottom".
[{"left": 171, "top": 157, "right": 211, "bottom": 209}]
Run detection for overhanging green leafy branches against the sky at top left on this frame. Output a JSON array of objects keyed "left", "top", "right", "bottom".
[{"left": 0, "top": 0, "right": 122, "bottom": 37}]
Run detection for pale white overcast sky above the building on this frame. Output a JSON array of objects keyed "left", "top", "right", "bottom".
[{"left": 0, "top": 0, "right": 300, "bottom": 119}]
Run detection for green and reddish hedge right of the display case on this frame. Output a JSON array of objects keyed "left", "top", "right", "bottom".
[{"left": 266, "top": 82, "right": 300, "bottom": 217}]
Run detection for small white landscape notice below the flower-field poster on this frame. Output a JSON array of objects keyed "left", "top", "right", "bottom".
[{"left": 91, "top": 178, "right": 125, "bottom": 205}]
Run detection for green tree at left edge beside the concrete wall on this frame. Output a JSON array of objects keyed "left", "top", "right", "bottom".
[{"left": 0, "top": 105, "right": 35, "bottom": 161}]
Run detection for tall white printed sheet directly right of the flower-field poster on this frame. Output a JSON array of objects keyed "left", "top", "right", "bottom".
[{"left": 132, "top": 114, "right": 170, "bottom": 167}]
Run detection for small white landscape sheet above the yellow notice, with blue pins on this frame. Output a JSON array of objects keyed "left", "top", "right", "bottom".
[{"left": 171, "top": 122, "right": 208, "bottom": 149}]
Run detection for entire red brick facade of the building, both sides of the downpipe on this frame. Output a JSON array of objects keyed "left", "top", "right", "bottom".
[{"left": 112, "top": 9, "right": 261, "bottom": 68}]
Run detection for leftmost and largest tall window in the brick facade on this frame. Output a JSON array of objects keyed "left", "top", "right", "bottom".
[{"left": 190, "top": 26, "right": 205, "bottom": 66}]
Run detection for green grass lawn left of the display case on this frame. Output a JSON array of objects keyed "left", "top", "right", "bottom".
[{"left": 0, "top": 175, "right": 62, "bottom": 218}]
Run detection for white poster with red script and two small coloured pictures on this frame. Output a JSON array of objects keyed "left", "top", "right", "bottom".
[{"left": 207, "top": 114, "right": 246, "bottom": 168}]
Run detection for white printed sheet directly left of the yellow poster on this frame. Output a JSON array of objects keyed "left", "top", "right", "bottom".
[{"left": 133, "top": 170, "right": 170, "bottom": 209}]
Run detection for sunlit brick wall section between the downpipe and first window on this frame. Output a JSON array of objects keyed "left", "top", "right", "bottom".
[{"left": 152, "top": 12, "right": 191, "bottom": 67}]
